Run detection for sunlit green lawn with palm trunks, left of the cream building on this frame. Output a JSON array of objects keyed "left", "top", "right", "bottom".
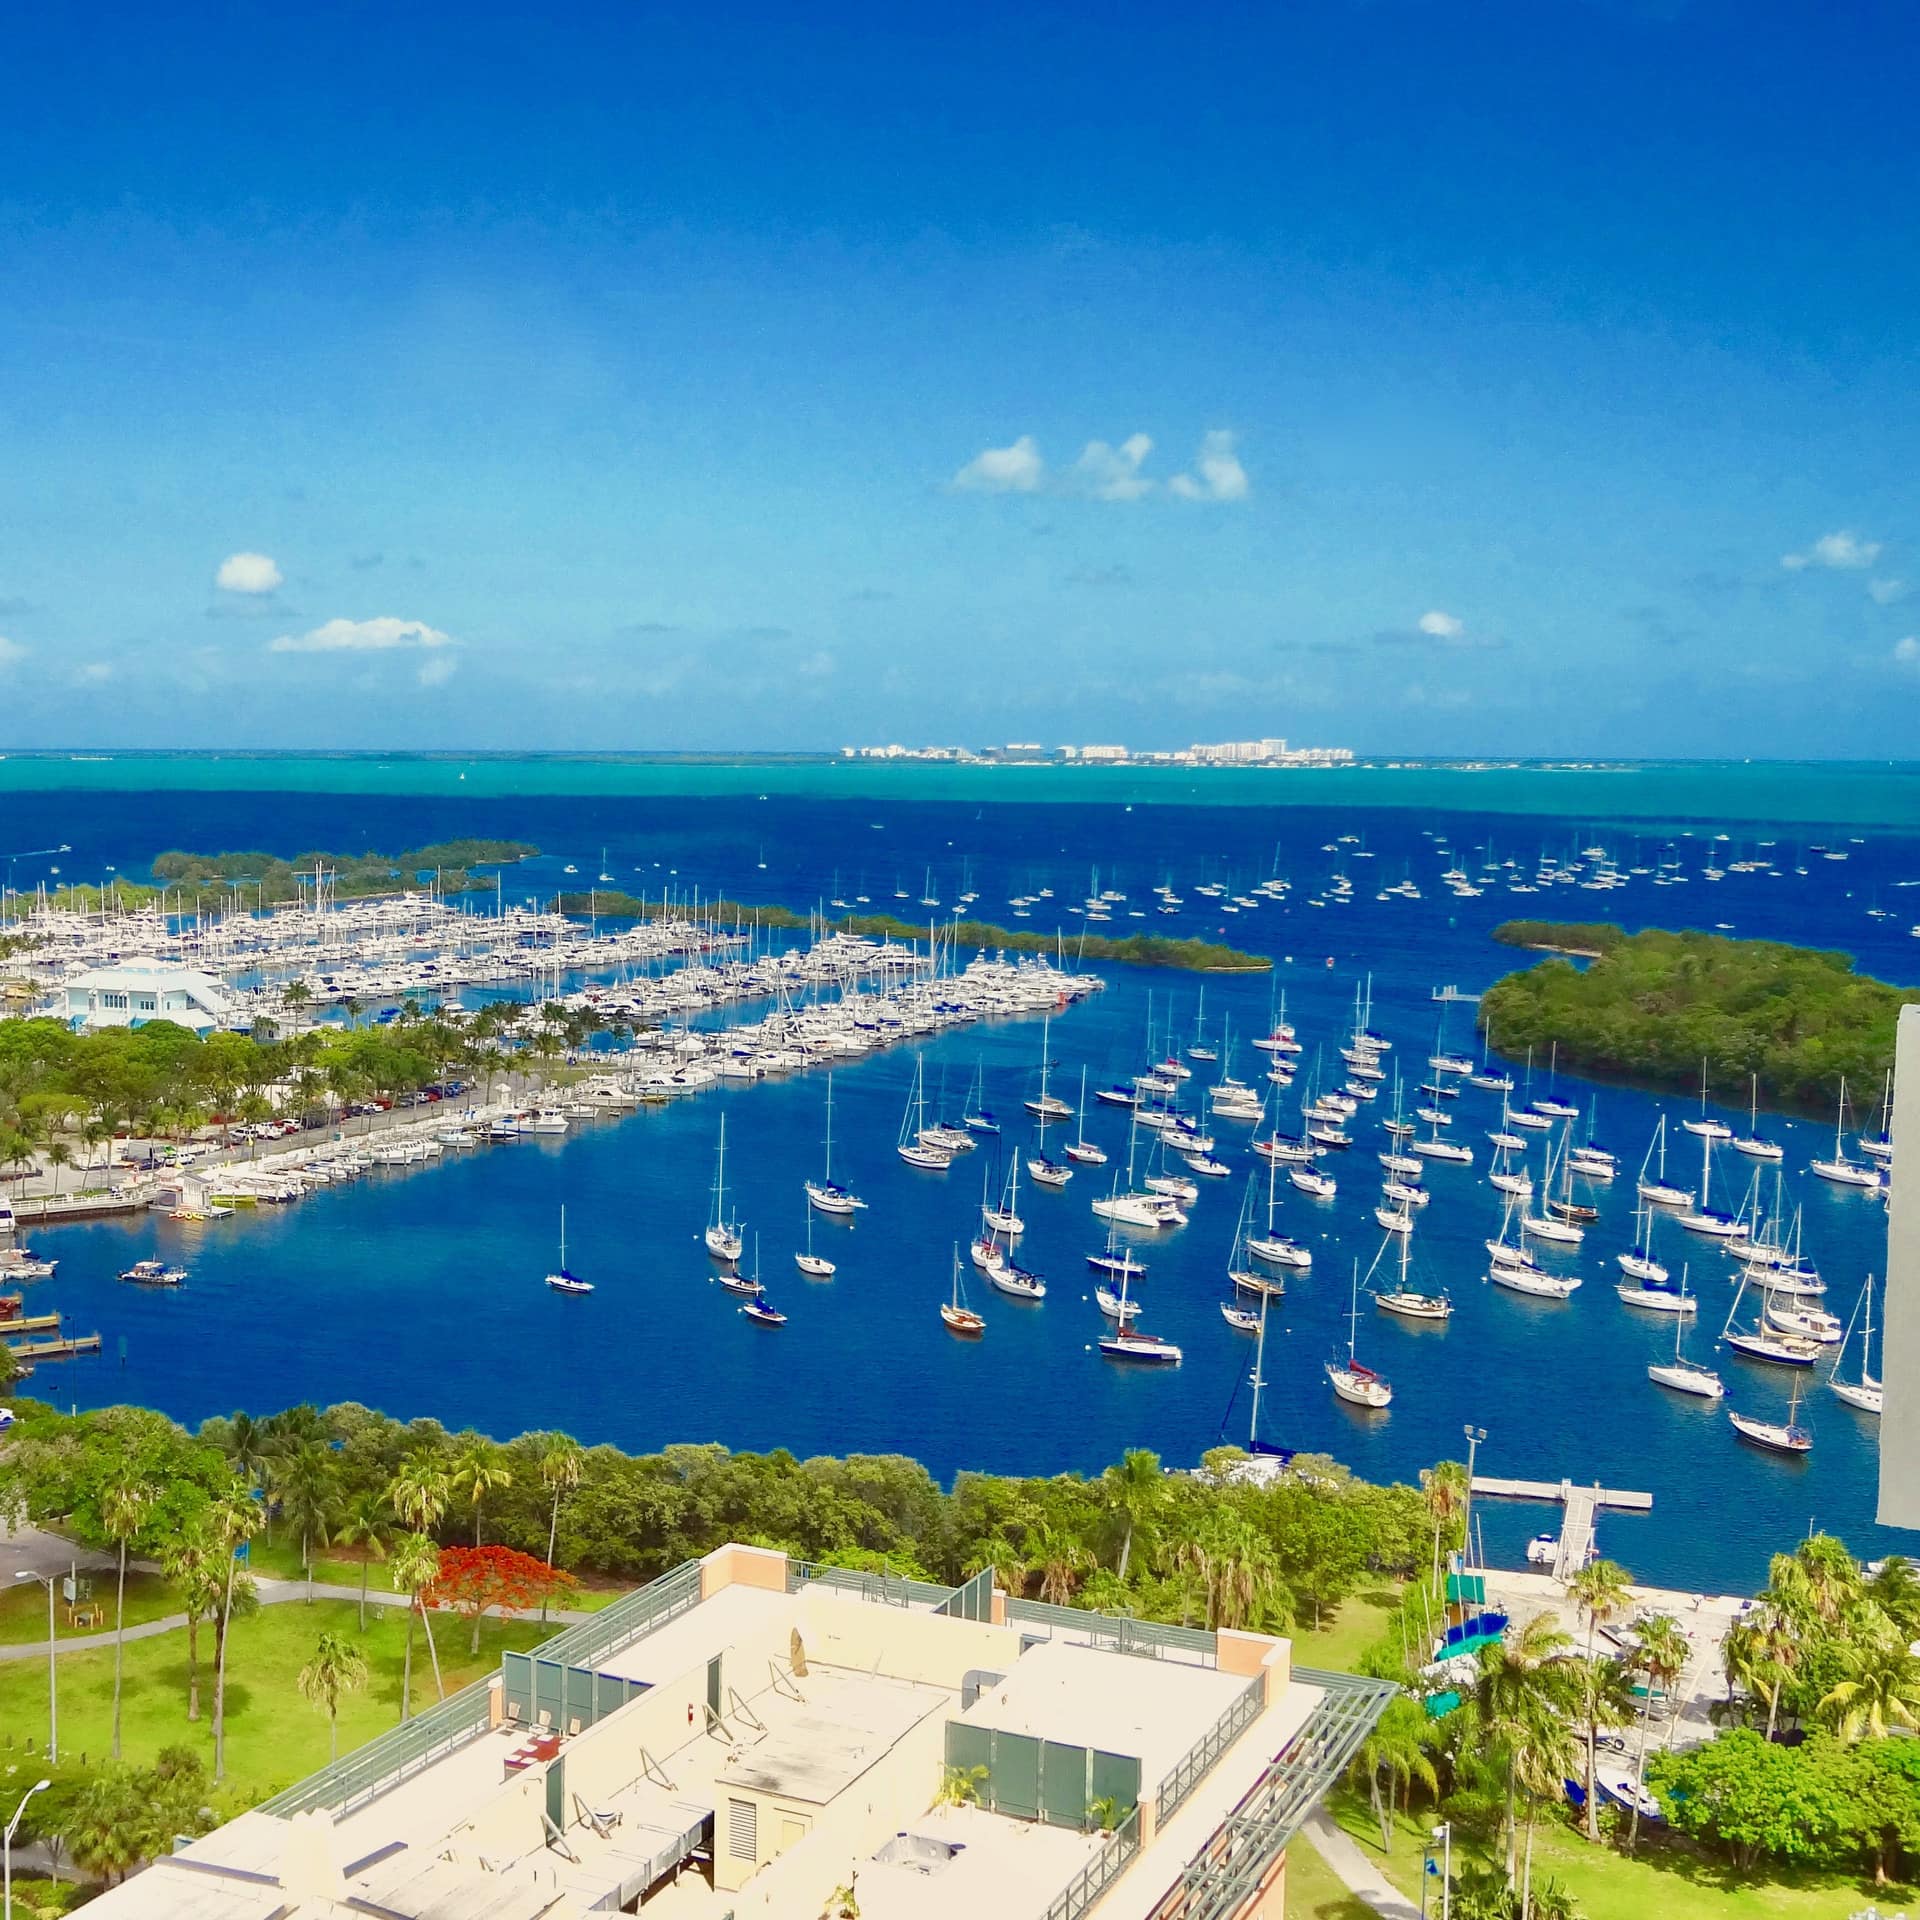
[{"left": 0, "top": 1599, "right": 551, "bottom": 1797}]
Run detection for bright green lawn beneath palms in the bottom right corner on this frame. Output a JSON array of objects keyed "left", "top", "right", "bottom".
[{"left": 1327, "top": 1788, "right": 1916, "bottom": 1920}]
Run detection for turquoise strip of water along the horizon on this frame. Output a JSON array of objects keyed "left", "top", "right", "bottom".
[{"left": 11, "top": 753, "right": 1920, "bottom": 829}]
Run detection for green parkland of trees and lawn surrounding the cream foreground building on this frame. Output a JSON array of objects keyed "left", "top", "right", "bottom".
[{"left": 0, "top": 1400, "right": 1920, "bottom": 1920}]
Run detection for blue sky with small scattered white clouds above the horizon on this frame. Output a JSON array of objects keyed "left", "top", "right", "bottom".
[{"left": 0, "top": 0, "right": 1920, "bottom": 756}]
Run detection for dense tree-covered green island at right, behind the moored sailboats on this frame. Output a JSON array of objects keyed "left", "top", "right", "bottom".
[{"left": 1480, "top": 920, "right": 1920, "bottom": 1114}]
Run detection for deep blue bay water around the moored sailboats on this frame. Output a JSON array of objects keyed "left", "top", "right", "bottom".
[{"left": 0, "top": 776, "right": 1920, "bottom": 1588}]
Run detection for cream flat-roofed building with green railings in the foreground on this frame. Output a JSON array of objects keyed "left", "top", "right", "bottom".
[{"left": 92, "top": 1546, "right": 1392, "bottom": 1920}]
